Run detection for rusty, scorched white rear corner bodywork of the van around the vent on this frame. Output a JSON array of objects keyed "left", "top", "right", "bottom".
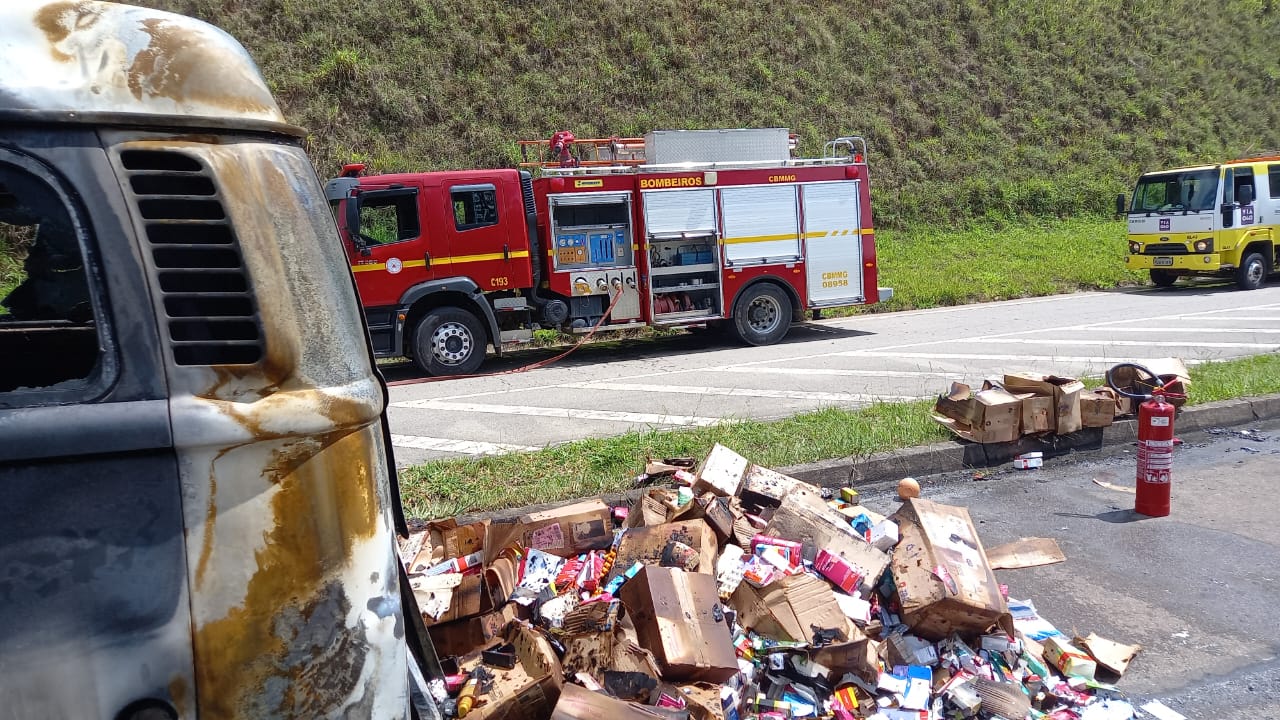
[{"left": 108, "top": 133, "right": 407, "bottom": 719}]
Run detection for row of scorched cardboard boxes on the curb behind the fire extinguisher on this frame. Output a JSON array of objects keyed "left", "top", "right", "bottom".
[{"left": 933, "top": 357, "right": 1190, "bottom": 443}]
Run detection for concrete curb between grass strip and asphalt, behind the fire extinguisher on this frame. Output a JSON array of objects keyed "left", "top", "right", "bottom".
[{"left": 777, "top": 395, "right": 1280, "bottom": 487}]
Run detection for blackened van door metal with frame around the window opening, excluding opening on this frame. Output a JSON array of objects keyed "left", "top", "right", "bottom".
[{"left": 0, "top": 127, "right": 195, "bottom": 719}]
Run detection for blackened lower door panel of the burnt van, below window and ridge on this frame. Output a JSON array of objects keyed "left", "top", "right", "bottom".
[{"left": 0, "top": 450, "right": 191, "bottom": 720}]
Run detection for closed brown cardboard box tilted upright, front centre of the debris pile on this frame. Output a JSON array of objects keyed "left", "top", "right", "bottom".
[{"left": 618, "top": 565, "right": 737, "bottom": 683}]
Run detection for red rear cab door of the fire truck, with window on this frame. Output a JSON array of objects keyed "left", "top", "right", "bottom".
[{"left": 440, "top": 174, "right": 532, "bottom": 291}]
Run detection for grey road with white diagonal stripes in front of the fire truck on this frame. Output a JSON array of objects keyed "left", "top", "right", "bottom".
[{"left": 384, "top": 283, "right": 1280, "bottom": 465}]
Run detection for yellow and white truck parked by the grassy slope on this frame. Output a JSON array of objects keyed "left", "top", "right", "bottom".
[{"left": 1116, "top": 155, "right": 1280, "bottom": 290}]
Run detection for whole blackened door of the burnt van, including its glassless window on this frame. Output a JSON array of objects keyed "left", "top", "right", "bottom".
[{"left": 0, "top": 128, "right": 192, "bottom": 719}]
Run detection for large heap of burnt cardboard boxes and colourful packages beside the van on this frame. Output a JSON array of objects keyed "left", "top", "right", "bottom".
[{"left": 401, "top": 446, "right": 1138, "bottom": 720}]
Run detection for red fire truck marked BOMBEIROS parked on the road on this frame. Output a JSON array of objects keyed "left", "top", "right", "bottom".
[{"left": 326, "top": 128, "right": 892, "bottom": 375}]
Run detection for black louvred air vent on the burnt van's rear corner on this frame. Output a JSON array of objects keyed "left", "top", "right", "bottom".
[{"left": 120, "top": 150, "right": 264, "bottom": 365}]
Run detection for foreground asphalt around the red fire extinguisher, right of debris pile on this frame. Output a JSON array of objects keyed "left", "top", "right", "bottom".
[{"left": 863, "top": 421, "right": 1280, "bottom": 720}]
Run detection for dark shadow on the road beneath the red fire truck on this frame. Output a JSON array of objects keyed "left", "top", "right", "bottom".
[{"left": 379, "top": 323, "right": 876, "bottom": 382}]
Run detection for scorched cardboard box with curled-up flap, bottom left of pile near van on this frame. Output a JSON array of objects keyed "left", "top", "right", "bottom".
[{"left": 462, "top": 621, "right": 564, "bottom": 720}]
